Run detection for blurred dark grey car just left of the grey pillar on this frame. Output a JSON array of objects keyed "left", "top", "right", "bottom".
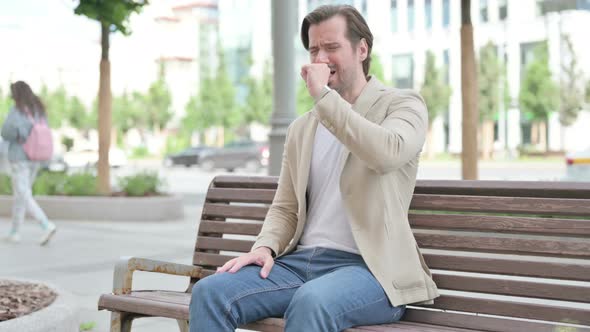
[{"left": 199, "top": 140, "right": 269, "bottom": 172}]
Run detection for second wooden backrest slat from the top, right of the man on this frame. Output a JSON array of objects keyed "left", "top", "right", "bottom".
[{"left": 410, "top": 194, "right": 590, "bottom": 216}]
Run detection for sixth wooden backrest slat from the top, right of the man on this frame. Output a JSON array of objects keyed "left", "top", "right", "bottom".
[{"left": 433, "top": 273, "right": 590, "bottom": 302}]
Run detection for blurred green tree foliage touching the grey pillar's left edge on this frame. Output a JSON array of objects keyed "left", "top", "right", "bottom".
[{"left": 242, "top": 61, "right": 273, "bottom": 125}]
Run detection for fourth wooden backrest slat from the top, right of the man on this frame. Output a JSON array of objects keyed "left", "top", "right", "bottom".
[{"left": 414, "top": 233, "right": 590, "bottom": 258}]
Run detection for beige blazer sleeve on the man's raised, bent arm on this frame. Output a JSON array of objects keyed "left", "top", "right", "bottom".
[{"left": 312, "top": 90, "right": 428, "bottom": 174}]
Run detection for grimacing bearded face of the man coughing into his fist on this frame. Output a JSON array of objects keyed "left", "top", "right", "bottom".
[{"left": 308, "top": 15, "right": 366, "bottom": 94}]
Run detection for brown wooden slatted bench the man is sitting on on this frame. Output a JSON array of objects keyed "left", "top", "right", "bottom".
[{"left": 99, "top": 176, "right": 590, "bottom": 332}]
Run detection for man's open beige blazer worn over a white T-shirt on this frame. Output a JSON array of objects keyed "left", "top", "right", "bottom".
[{"left": 253, "top": 78, "right": 438, "bottom": 306}]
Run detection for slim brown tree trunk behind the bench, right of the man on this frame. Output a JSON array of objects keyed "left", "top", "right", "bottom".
[{"left": 461, "top": 0, "right": 478, "bottom": 180}]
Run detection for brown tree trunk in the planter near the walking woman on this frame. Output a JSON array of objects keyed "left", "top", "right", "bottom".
[{"left": 98, "top": 24, "right": 112, "bottom": 195}]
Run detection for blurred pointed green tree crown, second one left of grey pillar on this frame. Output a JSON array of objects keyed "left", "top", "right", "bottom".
[{"left": 183, "top": 51, "right": 242, "bottom": 133}]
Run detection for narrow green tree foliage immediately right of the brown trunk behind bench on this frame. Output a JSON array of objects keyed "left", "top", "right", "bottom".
[{"left": 477, "top": 42, "right": 504, "bottom": 121}]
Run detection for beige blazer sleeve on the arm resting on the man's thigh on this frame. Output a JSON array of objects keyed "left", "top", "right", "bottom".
[{"left": 252, "top": 125, "right": 298, "bottom": 255}]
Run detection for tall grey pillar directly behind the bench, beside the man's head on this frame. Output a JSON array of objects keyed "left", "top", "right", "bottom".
[{"left": 268, "top": 0, "right": 298, "bottom": 175}]
